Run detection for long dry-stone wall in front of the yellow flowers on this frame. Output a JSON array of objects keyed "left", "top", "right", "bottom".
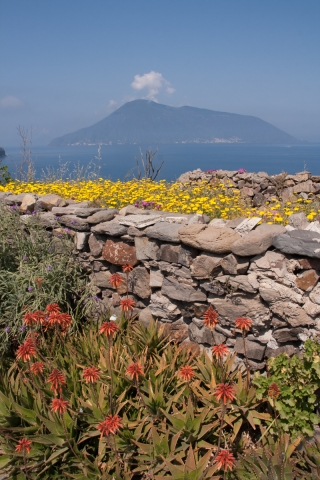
[{"left": 0, "top": 189, "right": 320, "bottom": 370}]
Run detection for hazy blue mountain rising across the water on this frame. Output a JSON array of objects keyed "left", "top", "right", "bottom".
[{"left": 49, "top": 100, "right": 298, "bottom": 146}]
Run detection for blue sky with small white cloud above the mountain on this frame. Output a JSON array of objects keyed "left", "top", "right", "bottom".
[{"left": 0, "top": 0, "right": 320, "bottom": 148}]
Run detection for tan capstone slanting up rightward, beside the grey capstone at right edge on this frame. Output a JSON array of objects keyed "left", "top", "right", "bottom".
[{"left": 231, "top": 224, "right": 286, "bottom": 257}]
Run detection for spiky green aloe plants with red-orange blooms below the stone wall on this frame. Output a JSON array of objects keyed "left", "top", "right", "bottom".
[{"left": 0, "top": 304, "right": 320, "bottom": 480}]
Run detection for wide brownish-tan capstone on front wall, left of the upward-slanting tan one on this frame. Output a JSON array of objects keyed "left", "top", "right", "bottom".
[{"left": 179, "top": 225, "right": 241, "bottom": 254}]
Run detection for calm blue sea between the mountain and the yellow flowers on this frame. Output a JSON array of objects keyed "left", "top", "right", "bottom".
[{"left": 4, "top": 143, "right": 320, "bottom": 180}]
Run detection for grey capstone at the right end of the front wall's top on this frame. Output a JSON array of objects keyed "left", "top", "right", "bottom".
[{"left": 273, "top": 230, "right": 320, "bottom": 258}]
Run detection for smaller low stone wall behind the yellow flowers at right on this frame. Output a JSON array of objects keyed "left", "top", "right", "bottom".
[{"left": 177, "top": 168, "right": 320, "bottom": 207}]
